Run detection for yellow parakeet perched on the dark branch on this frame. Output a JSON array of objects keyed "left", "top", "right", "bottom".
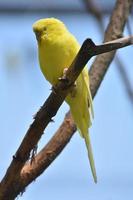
[{"left": 33, "top": 18, "right": 97, "bottom": 182}]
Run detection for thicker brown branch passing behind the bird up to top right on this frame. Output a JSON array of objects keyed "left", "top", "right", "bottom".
[{"left": 21, "top": 0, "right": 132, "bottom": 194}]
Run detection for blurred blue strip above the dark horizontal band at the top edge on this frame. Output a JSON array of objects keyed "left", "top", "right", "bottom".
[{"left": 0, "top": 0, "right": 115, "bottom": 10}]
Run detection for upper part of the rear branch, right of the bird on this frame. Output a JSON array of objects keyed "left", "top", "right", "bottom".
[{"left": 90, "top": 0, "right": 133, "bottom": 95}]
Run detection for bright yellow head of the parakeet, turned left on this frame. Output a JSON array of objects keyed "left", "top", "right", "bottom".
[{"left": 33, "top": 18, "right": 67, "bottom": 42}]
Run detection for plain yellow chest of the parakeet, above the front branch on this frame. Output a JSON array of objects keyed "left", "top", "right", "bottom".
[{"left": 39, "top": 42, "right": 73, "bottom": 85}]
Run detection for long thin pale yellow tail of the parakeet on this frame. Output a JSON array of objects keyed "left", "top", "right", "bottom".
[{"left": 83, "top": 133, "right": 97, "bottom": 183}]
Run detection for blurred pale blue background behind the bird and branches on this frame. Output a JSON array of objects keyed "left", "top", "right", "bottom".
[{"left": 0, "top": 0, "right": 133, "bottom": 200}]
